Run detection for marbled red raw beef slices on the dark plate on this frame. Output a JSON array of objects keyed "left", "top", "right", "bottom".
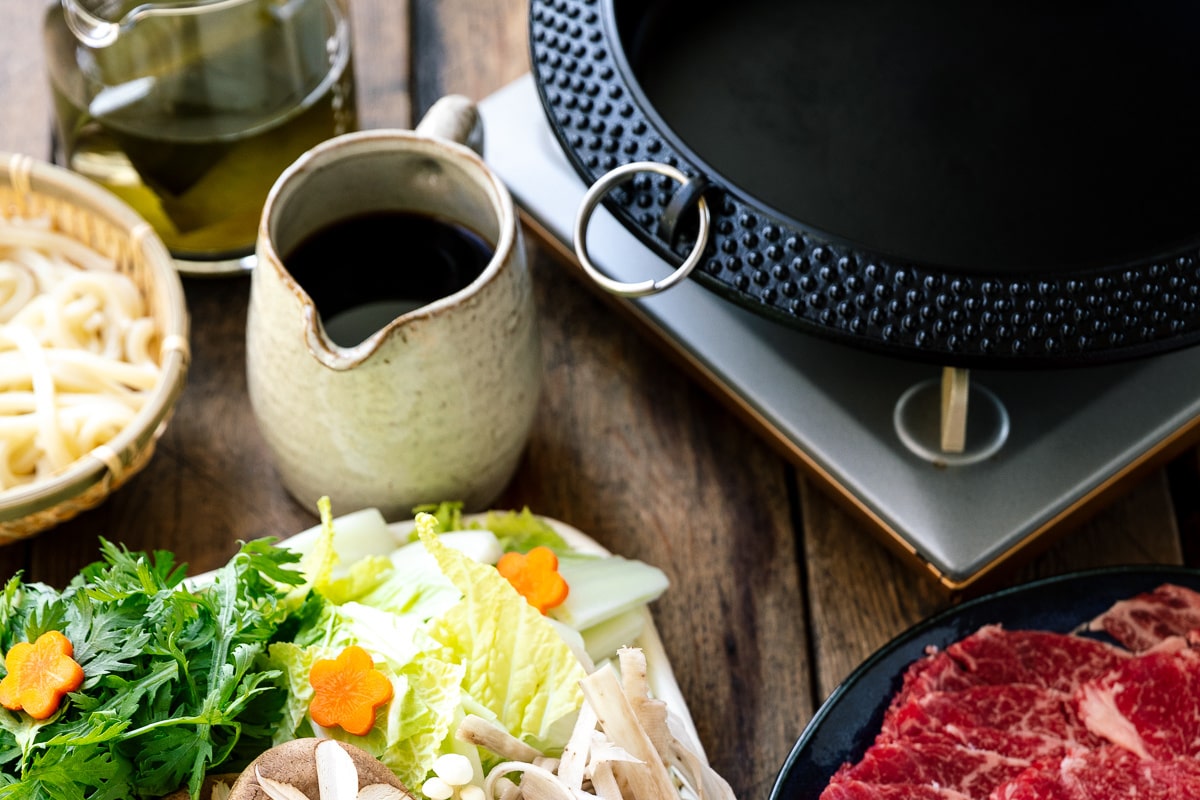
[{"left": 821, "top": 587, "right": 1200, "bottom": 800}]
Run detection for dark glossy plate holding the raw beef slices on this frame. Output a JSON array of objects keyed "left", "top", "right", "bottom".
[{"left": 770, "top": 566, "right": 1200, "bottom": 800}]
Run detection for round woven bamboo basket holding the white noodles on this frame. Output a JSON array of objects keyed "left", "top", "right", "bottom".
[{"left": 0, "top": 152, "right": 190, "bottom": 545}]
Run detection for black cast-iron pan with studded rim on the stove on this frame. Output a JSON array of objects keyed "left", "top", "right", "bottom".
[{"left": 530, "top": 0, "right": 1200, "bottom": 368}]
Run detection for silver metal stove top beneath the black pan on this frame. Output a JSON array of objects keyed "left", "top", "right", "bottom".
[{"left": 480, "top": 76, "right": 1200, "bottom": 587}]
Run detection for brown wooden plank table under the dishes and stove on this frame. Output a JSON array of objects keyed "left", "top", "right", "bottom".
[{"left": 0, "top": 0, "right": 1200, "bottom": 800}]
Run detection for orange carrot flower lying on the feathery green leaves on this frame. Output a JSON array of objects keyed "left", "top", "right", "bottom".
[{"left": 0, "top": 631, "right": 83, "bottom": 720}]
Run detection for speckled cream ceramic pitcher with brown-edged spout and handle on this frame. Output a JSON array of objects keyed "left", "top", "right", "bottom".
[{"left": 246, "top": 97, "right": 541, "bottom": 518}]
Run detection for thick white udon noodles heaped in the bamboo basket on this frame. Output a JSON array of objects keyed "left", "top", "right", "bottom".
[{"left": 0, "top": 219, "right": 160, "bottom": 491}]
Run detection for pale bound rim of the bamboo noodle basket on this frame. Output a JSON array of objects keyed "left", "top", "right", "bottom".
[{"left": 0, "top": 151, "right": 190, "bottom": 534}]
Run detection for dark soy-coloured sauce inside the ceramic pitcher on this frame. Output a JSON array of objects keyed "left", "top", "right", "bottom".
[{"left": 283, "top": 211, "right": 496, "bottom": 347}]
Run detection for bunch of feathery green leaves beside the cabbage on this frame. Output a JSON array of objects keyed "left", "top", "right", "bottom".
[{"left": 0, "top": 540, "right": 304, "bottom": 800}]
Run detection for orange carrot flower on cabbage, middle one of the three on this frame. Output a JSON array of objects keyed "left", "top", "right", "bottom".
[{"left": 308, "top": 644, "right": 392, "bottom": 736}]
